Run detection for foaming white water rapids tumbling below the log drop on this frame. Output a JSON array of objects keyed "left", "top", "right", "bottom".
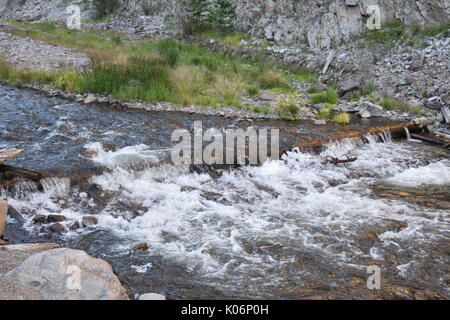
[{"left": 0, "top": 135, "right": 450, "bottom": 298}]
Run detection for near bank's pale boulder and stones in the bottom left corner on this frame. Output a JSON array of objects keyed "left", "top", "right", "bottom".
[{"left": 0, "top": 201, "right": 169, "bottom": 300}]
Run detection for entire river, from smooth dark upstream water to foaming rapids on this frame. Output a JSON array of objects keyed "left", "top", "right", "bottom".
[{"left": 0, "top": 86, "right": 450, "bottom": 299}]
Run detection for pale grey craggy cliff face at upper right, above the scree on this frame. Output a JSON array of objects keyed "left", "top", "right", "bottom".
[{"left": 237, "top": 0, "right": 450, "bottom": 48}]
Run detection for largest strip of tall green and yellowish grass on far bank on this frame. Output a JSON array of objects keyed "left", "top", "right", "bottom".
[{"left": 0, "top": 22, "right": 316, "bottom": 109}]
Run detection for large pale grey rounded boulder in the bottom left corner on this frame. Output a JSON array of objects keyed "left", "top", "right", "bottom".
[{"left": 5, "top": 248, "right": 128, "bottom": 300}]
